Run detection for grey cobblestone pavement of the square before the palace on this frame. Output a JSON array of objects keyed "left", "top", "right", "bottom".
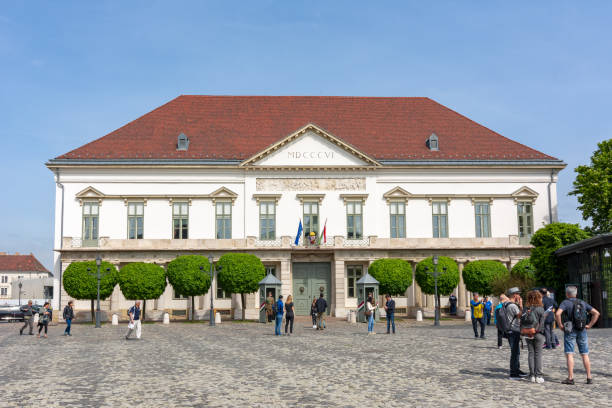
[{"left": 0, "top": 320, "right": 612, "bottom": 407}]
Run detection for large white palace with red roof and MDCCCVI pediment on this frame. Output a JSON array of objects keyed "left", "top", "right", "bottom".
[{"left": 47, "top": 95, "right": 565, "bottom": 318}]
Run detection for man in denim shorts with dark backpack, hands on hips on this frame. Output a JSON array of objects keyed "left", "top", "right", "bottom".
[{"left": 555, "top": 286, "right": 599, "bottom": 385}]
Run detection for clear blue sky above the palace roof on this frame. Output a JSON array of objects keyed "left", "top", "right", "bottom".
[{"left": 0, "top": 0, "right": 612, "bottom": 268}]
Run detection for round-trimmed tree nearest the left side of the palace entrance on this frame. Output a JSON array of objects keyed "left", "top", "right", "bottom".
[{"left": 217, "top": 253, "right": 266, "bottom": 320}]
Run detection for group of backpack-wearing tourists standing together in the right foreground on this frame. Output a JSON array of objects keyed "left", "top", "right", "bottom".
[{"left": 494, "top": 286, "right": 599, "bottom": 384}]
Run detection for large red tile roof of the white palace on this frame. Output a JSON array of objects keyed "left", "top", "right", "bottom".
[{"left": 57, "top": 95, "right": 558, "bottom": 161}]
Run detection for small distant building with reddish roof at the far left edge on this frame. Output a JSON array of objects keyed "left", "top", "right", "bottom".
[{"left": 0, "top": 252, "right": 54, "bottom": 305}]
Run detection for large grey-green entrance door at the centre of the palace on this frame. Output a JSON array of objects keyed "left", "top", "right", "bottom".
[{"left": 293, "top": 262, "right": 331, "bottom": 316}]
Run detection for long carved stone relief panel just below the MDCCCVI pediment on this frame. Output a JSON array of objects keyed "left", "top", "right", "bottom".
[{"left": 255, "top": 177, "right": 366, "bottom": 191}]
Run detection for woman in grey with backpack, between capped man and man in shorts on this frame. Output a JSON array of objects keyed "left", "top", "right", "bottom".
[{"left": 521, "top": 290, "right": 547, "bottom": 384}]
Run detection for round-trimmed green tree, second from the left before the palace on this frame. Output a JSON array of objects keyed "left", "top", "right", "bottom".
[{"left": 117, "top": 262, "right": 167, "bottom": 321}]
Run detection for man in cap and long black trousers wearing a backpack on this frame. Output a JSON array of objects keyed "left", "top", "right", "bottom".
[{"left": 497, "top": 287, "right": 527, "bottom": 380}]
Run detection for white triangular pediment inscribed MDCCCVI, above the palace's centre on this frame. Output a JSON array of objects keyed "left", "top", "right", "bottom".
[{"left": 241, "top": 124, "right": 380, "bottom": 168}]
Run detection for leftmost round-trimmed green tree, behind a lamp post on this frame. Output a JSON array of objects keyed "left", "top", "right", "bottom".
[{"left": 62, "top": 261, "right": 117, "bottom": 322}]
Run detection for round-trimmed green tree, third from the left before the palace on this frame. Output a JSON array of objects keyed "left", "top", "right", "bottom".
[{"left": 166, "top": 255, "right": 210, "bottom": 320}]
